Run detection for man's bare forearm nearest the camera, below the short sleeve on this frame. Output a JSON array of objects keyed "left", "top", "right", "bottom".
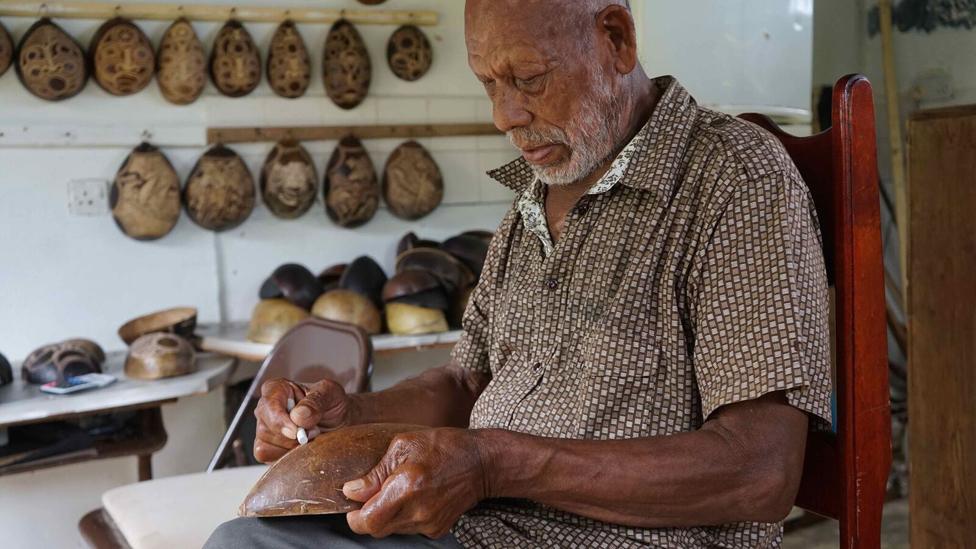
[{"left": 479, "top": 394, "right": 806, "bottom": 528}]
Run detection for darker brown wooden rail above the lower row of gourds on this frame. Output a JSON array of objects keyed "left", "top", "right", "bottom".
[{"left": 207, "top": 123, "right": 502, "bottom": 145}]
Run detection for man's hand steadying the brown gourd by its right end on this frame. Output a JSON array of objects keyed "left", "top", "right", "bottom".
[{"left": 342, "top": 428, "right": 487, "bottom": 539}]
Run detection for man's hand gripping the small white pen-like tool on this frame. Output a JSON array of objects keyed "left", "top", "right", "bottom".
[{"left": 254, "top": 379, "right": 351, "bottom": 463}]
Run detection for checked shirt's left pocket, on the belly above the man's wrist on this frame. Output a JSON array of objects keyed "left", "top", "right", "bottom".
[{"left": 470, "top": 351, "right": 543, "bottom": 430}]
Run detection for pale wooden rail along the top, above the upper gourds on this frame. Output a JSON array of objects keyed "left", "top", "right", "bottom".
[{"left": 0, "top": 0, "right": 440, "bottom": 26}]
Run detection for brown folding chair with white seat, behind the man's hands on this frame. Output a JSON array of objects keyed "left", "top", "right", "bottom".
[{"left": 78, "top": 319, "right": 372, "bottom": 549}]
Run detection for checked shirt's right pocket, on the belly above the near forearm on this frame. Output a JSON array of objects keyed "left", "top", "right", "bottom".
[{"left": 579, "top": 341, "right": 663, "bottom": 440}]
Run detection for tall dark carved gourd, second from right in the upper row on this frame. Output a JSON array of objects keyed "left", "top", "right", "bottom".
[{"left": 322, "top": 19, "right": 373, "bottom": 109}]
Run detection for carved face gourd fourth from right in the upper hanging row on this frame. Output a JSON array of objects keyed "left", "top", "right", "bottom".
[{"left": 210, "top": 19, "right": 261, "bottom": 97}]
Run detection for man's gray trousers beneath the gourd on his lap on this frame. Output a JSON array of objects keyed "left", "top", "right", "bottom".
[{"left": 204, "top": 515, "right": 461, "bottom": 549}]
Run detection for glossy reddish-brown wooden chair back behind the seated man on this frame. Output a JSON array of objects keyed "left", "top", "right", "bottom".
[{"left": 742, "top": 75, "right": 891, "bottom": 548}]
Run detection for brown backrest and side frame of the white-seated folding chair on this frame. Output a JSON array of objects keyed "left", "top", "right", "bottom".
[{"left": 207, "top": 318, "right": 373, "bottom": 472}]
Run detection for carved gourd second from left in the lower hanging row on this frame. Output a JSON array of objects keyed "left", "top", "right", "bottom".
[{"left": 183, "top": 145, "right": 255, "bottom": 232}]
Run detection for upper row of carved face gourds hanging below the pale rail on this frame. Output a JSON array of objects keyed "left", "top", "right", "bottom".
[{"left": 0, "top": 11, "right": 433, "bottom": 105}]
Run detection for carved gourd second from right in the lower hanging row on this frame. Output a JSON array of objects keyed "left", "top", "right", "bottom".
[{"left": 325, "top": 136, "right": 380, "bottom": 227}]
